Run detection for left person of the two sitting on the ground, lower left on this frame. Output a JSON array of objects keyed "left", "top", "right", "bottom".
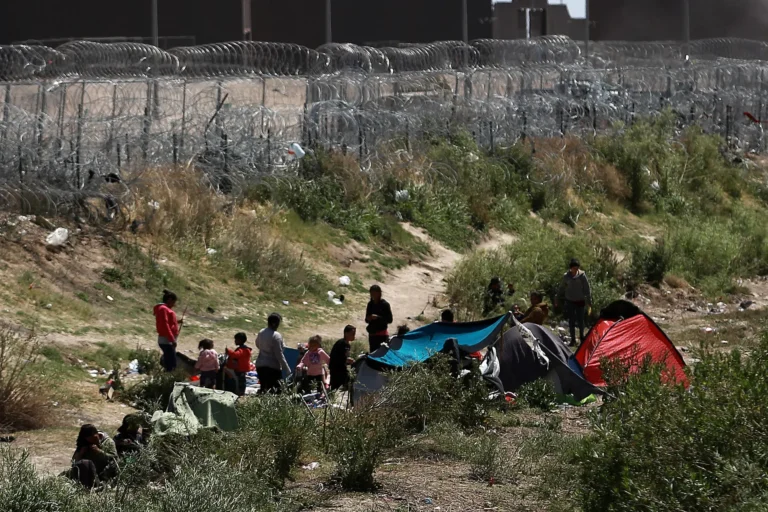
[{"left": 68, "top": 424, "right": 117, "bottom": 489}]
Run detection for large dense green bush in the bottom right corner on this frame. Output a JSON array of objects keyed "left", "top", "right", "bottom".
[{"left": 576, "top": 336, "right": 768, "bottom": 512}]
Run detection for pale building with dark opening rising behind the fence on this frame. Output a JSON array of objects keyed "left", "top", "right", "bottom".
[{"left": 493, "top": 0, "right": 586, "bottom": 39}]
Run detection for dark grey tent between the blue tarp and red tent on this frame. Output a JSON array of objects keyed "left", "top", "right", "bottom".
[{"left": 496, "top": 323, "right": 602, "bottom": 401}]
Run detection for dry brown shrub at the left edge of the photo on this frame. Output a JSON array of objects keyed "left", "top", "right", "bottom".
[{"left": 0, "top": 322, "right": 49, "bottom": 432}]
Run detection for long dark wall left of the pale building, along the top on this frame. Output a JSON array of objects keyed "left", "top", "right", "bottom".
[{"left": 0, "top": 0, "right": 493, "bottom": 48}]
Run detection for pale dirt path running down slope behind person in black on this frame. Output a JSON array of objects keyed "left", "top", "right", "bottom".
[{"left": 290, "top": 224, "right": 515, "bottom": 341}]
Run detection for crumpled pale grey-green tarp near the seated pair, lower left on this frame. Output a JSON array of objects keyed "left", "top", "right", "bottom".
[{"left": 152, "top": 382, "right": 238, "bottom": 436}]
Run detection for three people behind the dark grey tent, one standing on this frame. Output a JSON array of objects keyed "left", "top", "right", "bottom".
[{"left": 483, "top": 258, "right": 592, "bottom": 345}]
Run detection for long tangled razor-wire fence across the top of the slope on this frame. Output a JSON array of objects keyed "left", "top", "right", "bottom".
[{"left": 0, "top": 37, "right": 768, "bottom": 218}]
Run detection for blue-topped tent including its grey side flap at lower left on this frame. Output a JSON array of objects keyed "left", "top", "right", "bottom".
[{"left": 352, "top": 314, "right": 510, "bottom": 401}]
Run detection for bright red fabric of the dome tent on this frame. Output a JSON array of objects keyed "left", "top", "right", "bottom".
[{"left": 575, "top": 315, "right": 688, "bottom": 387}]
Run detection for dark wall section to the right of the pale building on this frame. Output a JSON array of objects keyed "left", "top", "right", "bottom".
[{"left": 590, "top": 0, "right": 768, "bottom": 41}]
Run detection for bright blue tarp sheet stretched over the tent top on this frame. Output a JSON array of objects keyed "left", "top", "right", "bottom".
[{"left": 368, "top": 314, "right": 509, "bottom": 368}]
